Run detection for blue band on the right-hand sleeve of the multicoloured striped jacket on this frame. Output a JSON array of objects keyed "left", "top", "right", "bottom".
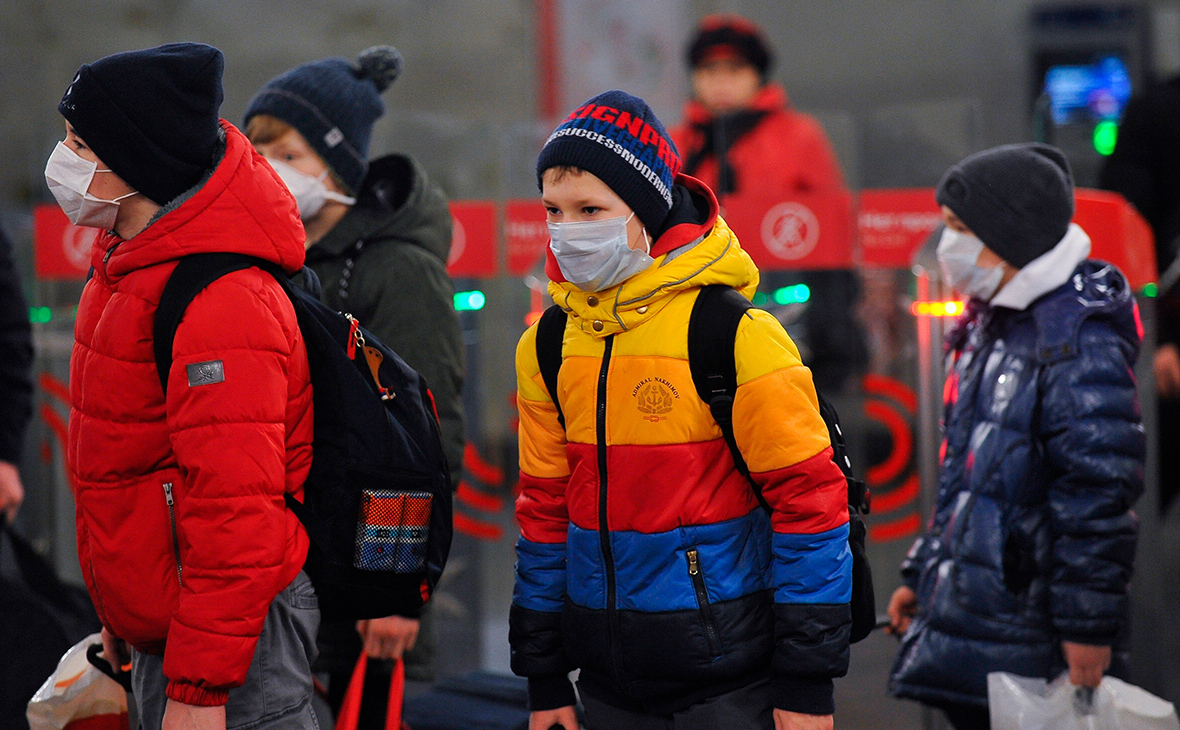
[{"left": 774, "top": 524, "right": 852, "bottom": 604}]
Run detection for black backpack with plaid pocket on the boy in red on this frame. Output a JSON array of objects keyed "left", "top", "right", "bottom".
[{"left": 152, "top": 254, "right": 452, "bottom": 619}]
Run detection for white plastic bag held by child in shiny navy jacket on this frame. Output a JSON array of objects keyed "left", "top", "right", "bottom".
[{"left": 988, "top": 672, "right": 1180, "bottom": 730}]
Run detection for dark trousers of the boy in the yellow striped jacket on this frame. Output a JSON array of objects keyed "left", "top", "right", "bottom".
[{"left": 582, "top": 679, "right": 774, "bottom": 730}]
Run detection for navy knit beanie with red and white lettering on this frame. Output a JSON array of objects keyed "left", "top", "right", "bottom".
[{"left": 537, "top": 91, "right": 680, "bottom": 231}]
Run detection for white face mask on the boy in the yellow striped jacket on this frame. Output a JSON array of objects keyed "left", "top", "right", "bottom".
[{"left": 549, "top": 212, "right": 655, "bottom": 291}]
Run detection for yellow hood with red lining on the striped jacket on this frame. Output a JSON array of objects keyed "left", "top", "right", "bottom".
[{"left": 545, "top": 176, "right": 759, "bottom": 337}]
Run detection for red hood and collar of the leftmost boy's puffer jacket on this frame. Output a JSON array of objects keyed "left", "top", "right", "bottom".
[{"left": 91, "top": 119, "right": 304, "bottom": 278}]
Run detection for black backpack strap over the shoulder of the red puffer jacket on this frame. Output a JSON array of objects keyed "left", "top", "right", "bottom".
[{"left": 152, "top": 254, "right": 290, "bottom": 395}]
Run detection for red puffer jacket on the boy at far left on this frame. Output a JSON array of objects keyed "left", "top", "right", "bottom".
[{"left": 68, "top": 120, "right": 312, "bottom": 705}]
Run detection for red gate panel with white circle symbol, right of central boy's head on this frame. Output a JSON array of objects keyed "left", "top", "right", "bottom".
[{"left": 721, "top": 192, "right": 853, "bottom": 271}]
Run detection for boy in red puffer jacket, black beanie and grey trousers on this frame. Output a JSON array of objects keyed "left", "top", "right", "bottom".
[{"left": 54, "top": 44, "right": 320, "bottom": 730}]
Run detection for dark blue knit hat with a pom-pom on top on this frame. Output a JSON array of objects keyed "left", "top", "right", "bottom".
[{"left": 242, "top": 46, "right": 402, "bottom": 193}]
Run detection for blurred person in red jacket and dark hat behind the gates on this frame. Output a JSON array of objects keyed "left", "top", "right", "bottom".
[{"left": 671, "top": 15, "right": 868, "bottom": 395}]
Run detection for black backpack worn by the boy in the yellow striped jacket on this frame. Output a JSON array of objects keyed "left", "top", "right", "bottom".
[{"left": 537, "top": 285, "right": 877, "bottom": 642}]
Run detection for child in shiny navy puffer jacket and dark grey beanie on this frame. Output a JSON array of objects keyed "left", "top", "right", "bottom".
[{"left": 889, "top": 144, "right": 1145, "bottom": 730}]
